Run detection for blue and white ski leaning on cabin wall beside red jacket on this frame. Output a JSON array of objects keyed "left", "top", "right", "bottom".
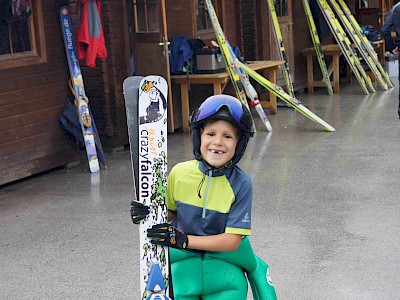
[{"left": 60, "top": 6, "right": 100, "bottom": 173}]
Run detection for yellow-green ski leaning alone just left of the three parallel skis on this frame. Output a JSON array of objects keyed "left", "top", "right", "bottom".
[{"left": 303, "top": 0, "right": 333, "bottom": 95}]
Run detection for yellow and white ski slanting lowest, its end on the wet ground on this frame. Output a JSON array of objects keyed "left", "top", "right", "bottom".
[{"left": 242, "top": 64, "right": 335, "bottom": 132}]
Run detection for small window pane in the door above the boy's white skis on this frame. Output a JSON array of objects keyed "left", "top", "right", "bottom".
[{"left": 134, "top": 0, "right": 160, "bottom": 33}]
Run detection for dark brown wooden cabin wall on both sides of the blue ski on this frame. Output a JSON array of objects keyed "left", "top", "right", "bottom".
[{"left": 0, "top": 0, "right": 129, "bottom": 185}]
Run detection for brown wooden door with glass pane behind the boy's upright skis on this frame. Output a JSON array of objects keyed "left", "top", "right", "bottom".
[{"left": 128, "top": 0, "right": 174, "bottom": 132}]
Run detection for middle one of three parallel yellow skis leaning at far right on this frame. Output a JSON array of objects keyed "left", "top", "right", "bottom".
[{"left": 330, "top": 0, "right": 388, "bottom": 91}]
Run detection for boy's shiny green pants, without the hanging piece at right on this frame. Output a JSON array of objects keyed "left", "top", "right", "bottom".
[{"left": 170, "top": 249, "right": 247, "bottom": 300}]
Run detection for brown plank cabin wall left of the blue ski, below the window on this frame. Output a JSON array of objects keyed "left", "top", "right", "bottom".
[{"left": 0, "top": 0, "right": 79, "bottom": 185}]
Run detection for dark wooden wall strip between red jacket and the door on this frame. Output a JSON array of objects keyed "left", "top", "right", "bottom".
[{"left": 94, "top": 0, "right": 130, "bottom": 152}]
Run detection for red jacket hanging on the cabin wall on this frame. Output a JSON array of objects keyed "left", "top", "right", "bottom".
[{"left": 76, "top": 0, "right": 107, "bottom": 67}]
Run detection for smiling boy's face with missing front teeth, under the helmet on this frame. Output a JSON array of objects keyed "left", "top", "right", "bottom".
[{"left": 200, "top": 120, "right": 238, "bottom": 168}]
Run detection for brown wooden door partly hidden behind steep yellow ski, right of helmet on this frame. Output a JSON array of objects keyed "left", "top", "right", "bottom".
[{"left": 270, "top": 0, "right": 295, "bottom": 85}]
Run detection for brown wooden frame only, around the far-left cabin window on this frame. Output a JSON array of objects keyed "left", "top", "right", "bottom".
[{"left": 0, "top": 0, "right": 47, "bottom": 70}]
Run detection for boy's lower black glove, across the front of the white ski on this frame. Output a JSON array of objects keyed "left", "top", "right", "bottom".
[{"left": 147, "top": 223, "right": 188, "bottom": 249}]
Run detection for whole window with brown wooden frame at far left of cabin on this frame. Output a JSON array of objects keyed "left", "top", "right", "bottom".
[{"left": 0, "top": 0, "right": 45, "bottom": 69}]
